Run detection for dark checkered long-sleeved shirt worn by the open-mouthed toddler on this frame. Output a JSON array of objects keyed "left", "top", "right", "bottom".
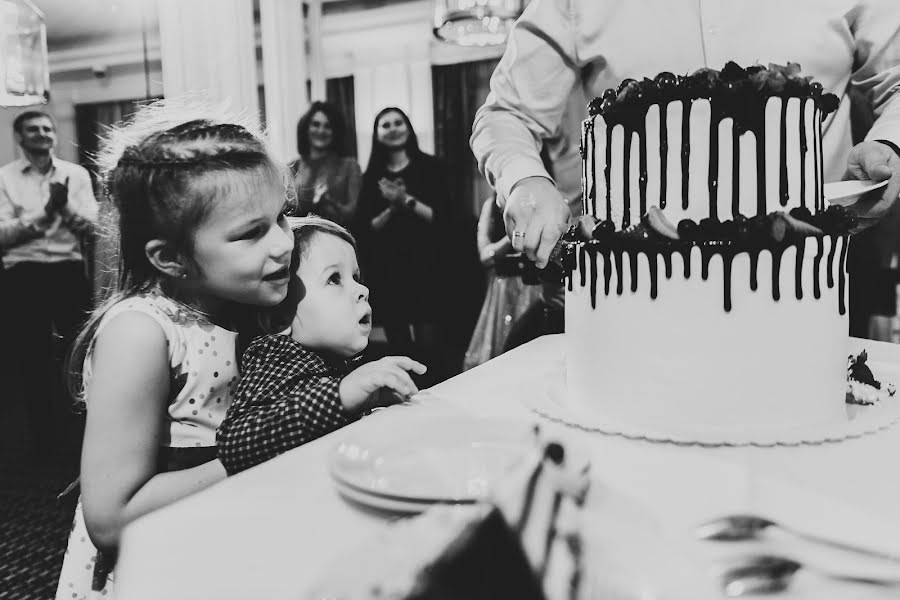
[{"left": 216, "top": 334, "right": 356, "bottom": 475}]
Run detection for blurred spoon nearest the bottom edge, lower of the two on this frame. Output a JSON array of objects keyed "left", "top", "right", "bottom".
[{"left": 721, "top": 554, "right": 900, "bottom": 598}]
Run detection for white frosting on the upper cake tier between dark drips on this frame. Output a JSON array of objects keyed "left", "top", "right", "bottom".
[{"left": 584, "top": 97, "right": 822, "bottom": 228}]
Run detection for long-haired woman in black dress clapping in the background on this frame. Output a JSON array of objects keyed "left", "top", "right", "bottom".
[{"left": 354, "top": 107, "right": 449, "bottom": 381}]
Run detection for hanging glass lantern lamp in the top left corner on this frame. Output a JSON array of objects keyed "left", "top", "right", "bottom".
[{"left": 0, "top": 0, "right": 50, "bottom": 106}]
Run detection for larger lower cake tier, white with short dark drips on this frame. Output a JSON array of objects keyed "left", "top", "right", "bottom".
[{"left": 565, "top": 236, "right": 848, "bottom": 440}]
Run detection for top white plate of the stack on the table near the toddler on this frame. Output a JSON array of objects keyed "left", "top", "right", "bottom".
[{"left": 329, "top": 415, "right": 534, "bottom": 503}]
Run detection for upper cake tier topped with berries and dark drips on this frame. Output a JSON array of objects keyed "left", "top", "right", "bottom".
[{"left": 582, "top": 62, "right": 838, "bottom": 228}]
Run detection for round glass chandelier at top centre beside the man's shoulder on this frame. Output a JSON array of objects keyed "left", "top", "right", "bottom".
[{"left": 434, "top": 0, "right": 528, "bottom": 46}]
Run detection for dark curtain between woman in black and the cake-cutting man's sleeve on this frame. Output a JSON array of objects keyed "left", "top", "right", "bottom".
[{"left": 431, "top": 59, "right": 498, "bottom": 216}]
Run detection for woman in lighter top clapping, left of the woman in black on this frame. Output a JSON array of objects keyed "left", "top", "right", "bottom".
[{"left": 290, "top": 102, "right": 362, "bottom": 226}]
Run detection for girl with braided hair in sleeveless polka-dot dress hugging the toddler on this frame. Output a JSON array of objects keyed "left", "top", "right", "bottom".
[{"left": 57, "top": 103, "right": 293, "bottom": 599}]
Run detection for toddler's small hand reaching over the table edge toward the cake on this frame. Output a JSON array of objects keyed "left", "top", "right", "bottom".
[{"left": 338, "top": 356, "right": 426, "bottom": 413}]
